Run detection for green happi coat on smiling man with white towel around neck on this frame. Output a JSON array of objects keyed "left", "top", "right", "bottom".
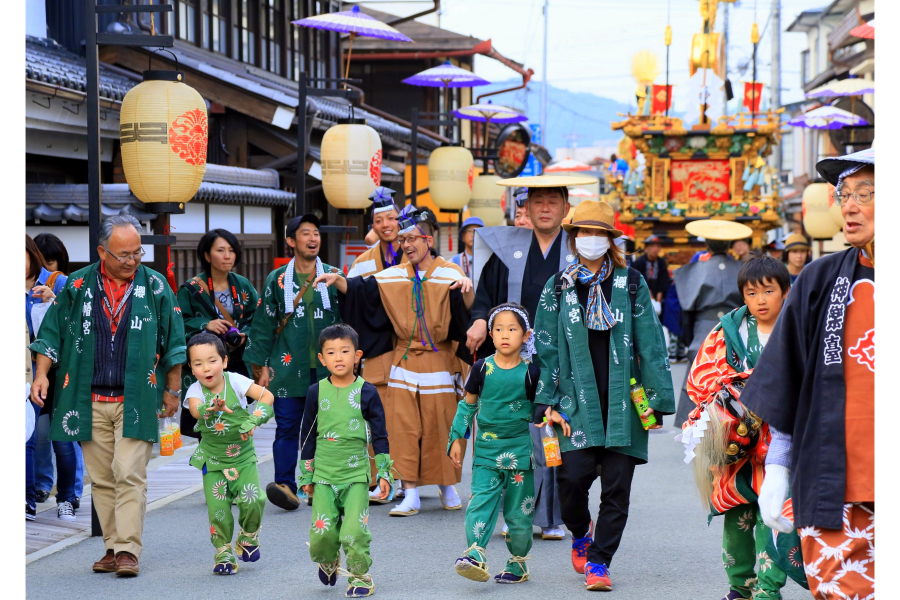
[{"left": 244, "top": 264, "right": 341, "bottom": 398}]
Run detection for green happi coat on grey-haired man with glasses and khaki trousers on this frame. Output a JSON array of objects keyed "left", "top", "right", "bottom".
[{"left": 31, "top": 263, "right": 186, "bottom": 442}]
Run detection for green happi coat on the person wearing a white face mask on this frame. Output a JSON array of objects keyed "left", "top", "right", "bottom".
[{"left": 534, "top": 268, "right": 675, "bottom": 463}]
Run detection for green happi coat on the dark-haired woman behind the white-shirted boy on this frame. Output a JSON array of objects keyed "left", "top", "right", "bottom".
[{"left": 178, "top": 271, "right": 260, "bottom": 393}]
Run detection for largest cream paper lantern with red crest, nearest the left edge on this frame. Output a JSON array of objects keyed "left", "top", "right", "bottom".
[{"left": 119, "top": 71, "right": 208, "bottom": 204}]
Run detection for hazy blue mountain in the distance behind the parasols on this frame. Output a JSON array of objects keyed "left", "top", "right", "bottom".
[{"left": 472, "top": 80, "right": 635, "bottom": 159}]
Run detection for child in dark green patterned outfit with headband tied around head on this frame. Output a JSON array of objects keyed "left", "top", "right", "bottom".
[{"left": 447, "top": 303, "right": 571, "bottom": 583}]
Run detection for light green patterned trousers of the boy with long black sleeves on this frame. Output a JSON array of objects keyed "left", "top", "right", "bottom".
[{"left": 309, "top": 482, "right": 372, "bottom": 575}]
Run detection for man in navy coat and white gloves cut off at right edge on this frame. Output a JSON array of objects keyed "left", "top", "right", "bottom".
[{"left": 741, "top": 148, "right": 876, "bottom": 599}]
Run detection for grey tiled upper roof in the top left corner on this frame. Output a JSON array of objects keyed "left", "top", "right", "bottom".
[{"left": 25, "top": 35, "right": 140, "bottom": 101}]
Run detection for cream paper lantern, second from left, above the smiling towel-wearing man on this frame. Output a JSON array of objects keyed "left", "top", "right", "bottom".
[{"left": 322, "top": 119, "right": 382, "bottom": 210}]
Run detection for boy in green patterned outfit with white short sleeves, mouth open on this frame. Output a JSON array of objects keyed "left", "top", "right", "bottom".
[{"left": 184, "top": 331, "right": 275, "bottom": 575}]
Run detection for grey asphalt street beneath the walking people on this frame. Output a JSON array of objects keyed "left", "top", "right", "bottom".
[{"left": 25, "top": 365, "right": 809, "bottom": 600}]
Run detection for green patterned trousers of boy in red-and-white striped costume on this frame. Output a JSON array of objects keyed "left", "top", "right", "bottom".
[{"left": 722, "top": 502, "right": 787, "bottom": 600}]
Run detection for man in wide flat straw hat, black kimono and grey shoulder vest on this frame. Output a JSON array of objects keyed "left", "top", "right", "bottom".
[{"left": 466, "top": 176, "right": 593, "bottom": 540}]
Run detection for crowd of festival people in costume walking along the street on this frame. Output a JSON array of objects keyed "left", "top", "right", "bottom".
[{"left": 25, "top": 150, "right": 875, "bottom": 600}]
